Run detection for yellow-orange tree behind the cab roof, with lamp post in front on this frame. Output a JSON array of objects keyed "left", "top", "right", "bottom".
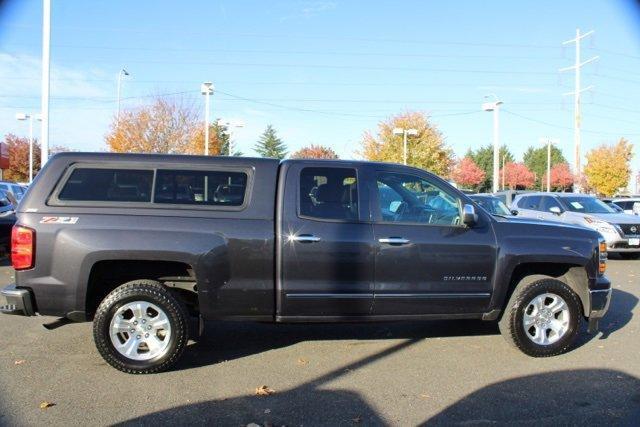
[{"left": 359, "top": 111, "right": 453, "bottom": 176}]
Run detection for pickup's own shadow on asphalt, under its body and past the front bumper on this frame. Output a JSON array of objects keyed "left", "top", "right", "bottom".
[{"left": 176, "top": 289, "right": 638, "bottom": 370}]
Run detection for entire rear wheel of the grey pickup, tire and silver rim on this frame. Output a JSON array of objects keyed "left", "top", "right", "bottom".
[{"left": 93, "top": 280, "right": 189, "bottom": 374}]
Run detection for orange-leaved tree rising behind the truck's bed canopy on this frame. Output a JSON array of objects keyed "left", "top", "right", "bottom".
[{"left": 105, "top": 98, "right": 201, "bottom": 154}]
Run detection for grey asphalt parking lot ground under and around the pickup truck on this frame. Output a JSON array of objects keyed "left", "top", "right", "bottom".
[{"left": 0, "top": 259, "right": 640, "bottom": 426}]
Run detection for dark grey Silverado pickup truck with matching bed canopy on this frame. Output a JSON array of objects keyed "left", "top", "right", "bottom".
[{"left": 0, "top": 153, "right": 611, "bottom": 373}]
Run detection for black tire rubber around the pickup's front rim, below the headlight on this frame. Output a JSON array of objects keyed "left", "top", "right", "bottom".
[{"left": 498, "top": 278, "right": 583, "bottom": 357}]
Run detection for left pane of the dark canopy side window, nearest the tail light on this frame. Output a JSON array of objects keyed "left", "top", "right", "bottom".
[{"left": 58, "top": 168, "right": 153, "bottom": 202}]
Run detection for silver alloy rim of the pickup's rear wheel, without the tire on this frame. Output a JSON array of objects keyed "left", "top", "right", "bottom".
[{"left": 109, "top": 301, "right": 171, "bottom": 361}]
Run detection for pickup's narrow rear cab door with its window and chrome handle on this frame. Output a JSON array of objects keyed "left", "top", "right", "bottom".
[{"left": 277, "top": 161, "right": 374, "bottom": 319}]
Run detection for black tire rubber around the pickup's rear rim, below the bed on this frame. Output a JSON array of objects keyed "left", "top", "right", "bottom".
[{"left": 93, "top": 280, "right": 189, "bottom": 374}]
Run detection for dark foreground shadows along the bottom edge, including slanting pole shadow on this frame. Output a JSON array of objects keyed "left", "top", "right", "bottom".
[{"left": 119, "top": 362, "right": 640, "bottom": 426}]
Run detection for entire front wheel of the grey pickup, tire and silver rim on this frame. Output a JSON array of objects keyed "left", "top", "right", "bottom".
[{"left": 499, "top": 278, "right": 582, "bottom": 357}]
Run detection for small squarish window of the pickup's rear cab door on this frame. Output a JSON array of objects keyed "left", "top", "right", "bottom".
[{"left": 300, "top": 168, "right": 358, "bottom": 221}]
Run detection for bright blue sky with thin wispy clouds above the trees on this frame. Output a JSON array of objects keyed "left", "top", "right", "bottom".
[{"left": 0, "top": 0, "right": 640, "bottom": 181}]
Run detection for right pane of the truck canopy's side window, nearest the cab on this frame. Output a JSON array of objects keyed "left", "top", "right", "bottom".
[{"left": 154, "top": 169, "right": 247, "bottom": 206}]
